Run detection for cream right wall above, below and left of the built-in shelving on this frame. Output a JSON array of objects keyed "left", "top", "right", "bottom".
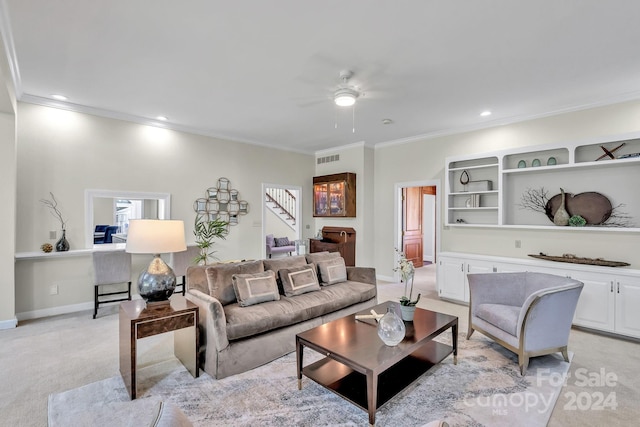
[{"left": 374, "top": 101, "right": 640, "bottom": 276}]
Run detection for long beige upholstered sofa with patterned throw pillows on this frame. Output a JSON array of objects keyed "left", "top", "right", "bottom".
[{"left": 186, "top": 252, "right": 377, "bottom": 378}]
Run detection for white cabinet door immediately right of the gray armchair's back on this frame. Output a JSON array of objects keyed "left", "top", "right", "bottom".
[{"left": 567, "top": 272, "right": 615, "bottom": 332}]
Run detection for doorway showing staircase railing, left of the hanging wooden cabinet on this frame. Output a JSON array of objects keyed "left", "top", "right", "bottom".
[{"left": 261, "top": 183, "right": 302, "bottom": 258}]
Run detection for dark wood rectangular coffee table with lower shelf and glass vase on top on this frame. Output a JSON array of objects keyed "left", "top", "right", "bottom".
[{"left": 296, "top": 302, "right": 458, "bottom": 425}]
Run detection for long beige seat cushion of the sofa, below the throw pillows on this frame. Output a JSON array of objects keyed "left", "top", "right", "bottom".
[{"left": 224, "top": 281, "right": 376, "bottom": 341}]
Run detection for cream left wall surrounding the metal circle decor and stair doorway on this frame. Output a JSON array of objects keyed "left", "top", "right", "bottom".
[{"left": 15, "top": 103, "right": 314, "bottom": 314}]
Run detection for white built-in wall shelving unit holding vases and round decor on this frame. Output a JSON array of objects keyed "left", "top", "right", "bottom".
[{"left": 445, "top": 133, "right": 640, "bottom": 232}]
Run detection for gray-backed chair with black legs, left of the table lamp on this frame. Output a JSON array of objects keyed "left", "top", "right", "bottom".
[{"left": 93, "top": 251, "right": 131, "bottom": 319}]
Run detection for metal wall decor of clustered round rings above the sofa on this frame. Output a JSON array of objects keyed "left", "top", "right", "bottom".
[{"left": 193, "top": 178, "right": 249, "bottom": 231}]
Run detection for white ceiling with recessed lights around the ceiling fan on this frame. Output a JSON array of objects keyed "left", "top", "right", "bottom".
[{"left": 0, "top": 0, "right": 640, "bottom": 153}]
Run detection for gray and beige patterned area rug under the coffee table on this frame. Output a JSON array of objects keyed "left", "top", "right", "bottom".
[{"left": 49, "top": 333, "right": 569, "bottom": 427}]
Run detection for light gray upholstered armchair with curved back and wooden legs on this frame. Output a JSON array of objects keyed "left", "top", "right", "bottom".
[{"left": 467, "top": 272, "right": 583, "bottom": 375}]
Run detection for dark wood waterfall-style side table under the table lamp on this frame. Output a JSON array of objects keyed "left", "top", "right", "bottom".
[{"left": 120, "top": 295, "right": 200, "bottom": 400}]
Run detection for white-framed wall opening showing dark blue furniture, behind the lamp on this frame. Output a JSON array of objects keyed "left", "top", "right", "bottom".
[{"left": 84, "top": 190, "right": 171, "bottom": 248}]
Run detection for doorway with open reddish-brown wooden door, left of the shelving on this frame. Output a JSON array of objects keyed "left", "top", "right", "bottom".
[{"left": 395, "top": 180, "right": 440, "bottom": 280}]
